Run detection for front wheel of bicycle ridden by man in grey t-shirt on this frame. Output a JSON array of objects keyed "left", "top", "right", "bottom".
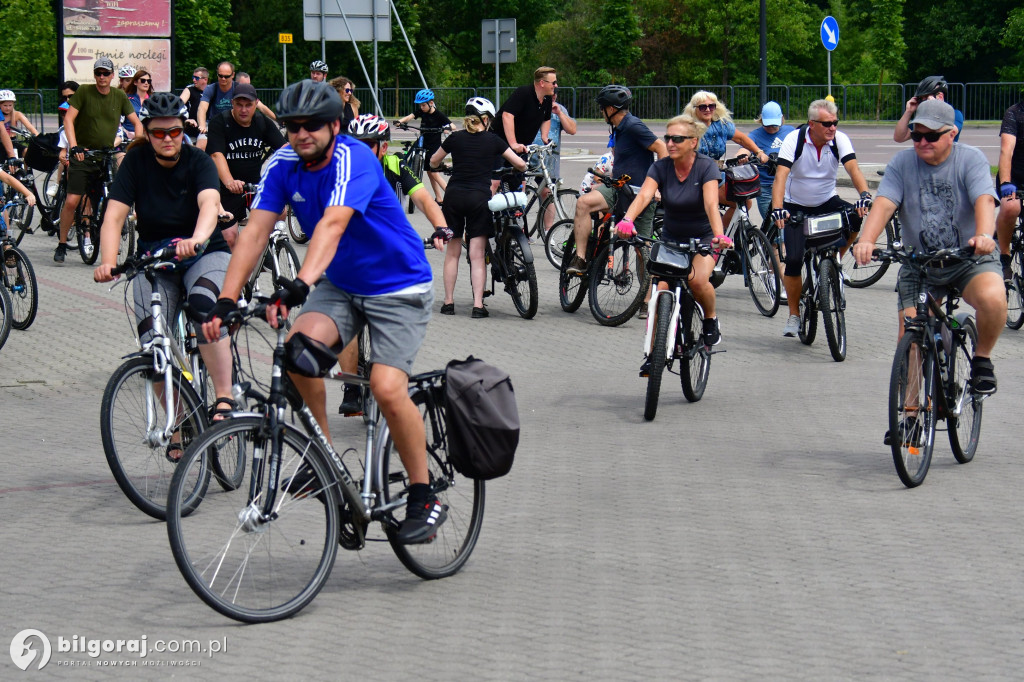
[{"left": 886, "top": 331, "right": 936, "bottom": 487}]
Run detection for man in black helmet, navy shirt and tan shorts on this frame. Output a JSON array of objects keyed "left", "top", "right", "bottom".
[{"left": 567, "top": 85, "right": 669, "bottom": 274}]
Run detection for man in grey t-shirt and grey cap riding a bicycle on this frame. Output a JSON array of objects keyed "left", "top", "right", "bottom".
[{"left": 853, "top": 99, "right": 1007, "bottom": 394}]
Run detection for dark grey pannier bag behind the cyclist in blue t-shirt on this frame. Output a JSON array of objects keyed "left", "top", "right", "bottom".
[{"left": 444, "top": 355, "right": 519, "bottom": 479}]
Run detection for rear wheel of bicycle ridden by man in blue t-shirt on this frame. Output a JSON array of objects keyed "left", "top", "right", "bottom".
[{"left": 381, "top": 388, "right": 485, "bottom": 580}]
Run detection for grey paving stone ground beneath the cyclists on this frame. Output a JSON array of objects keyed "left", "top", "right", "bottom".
[{"left": 0, "top": 160, "right": 1024, "bottom": 680}]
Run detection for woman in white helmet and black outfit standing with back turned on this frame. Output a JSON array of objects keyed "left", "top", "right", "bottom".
[{"left": 430, "top": 97, "right": 526, "bottom": 317}]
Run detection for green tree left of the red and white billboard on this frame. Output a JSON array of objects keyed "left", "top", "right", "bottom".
[{"left": 0, "top": 0, "right": 57, "bottom": 88}]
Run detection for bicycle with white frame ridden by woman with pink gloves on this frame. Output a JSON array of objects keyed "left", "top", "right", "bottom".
[{"left": 639, "top": 238, "right": 724, "bottom": 422}]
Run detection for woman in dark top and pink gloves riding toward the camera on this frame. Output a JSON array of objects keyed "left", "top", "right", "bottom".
[{"left": 615, "top": 114, "right": 732, "bottom": 346}]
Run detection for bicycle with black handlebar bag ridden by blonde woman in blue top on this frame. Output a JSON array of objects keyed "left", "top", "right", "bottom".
[{"left": 712, "top": 157, "right": 782, "bottom": 317}]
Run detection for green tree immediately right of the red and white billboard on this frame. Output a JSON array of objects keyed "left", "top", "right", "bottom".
[{"left": 174, "top": 0, "right": 241, "bottom": 83}]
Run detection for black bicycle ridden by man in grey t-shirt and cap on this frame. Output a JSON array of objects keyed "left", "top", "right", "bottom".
[{"left": 873, "top": 248, "right": 987, "bottom": 487}]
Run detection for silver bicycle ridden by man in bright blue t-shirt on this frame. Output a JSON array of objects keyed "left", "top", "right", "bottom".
[{"left": 167, "top": 305, "right": 484, "bottom": 623}]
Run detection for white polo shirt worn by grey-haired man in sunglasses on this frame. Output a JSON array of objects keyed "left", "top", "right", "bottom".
[{"left": 778, "top": 128, "right": 857, "bottom": 206}]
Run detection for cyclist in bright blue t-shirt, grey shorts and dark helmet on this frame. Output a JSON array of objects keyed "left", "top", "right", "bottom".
[{"left": 203, "top": 80, "right": 446, "bottom": 544}]
